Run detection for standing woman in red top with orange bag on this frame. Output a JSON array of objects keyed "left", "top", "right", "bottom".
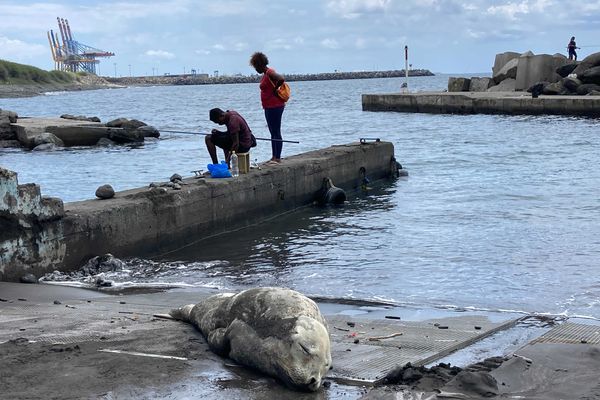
[{"left": 250, "top": 52, "right": 285, "bottom": 164}]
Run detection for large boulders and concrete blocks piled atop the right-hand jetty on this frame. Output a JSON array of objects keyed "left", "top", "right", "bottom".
[{"left": 448, "top": 51, "right": 600, "bottom": 97}]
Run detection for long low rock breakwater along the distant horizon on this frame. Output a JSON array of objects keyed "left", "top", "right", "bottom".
[{"left": 106, "top": 69, "right": 433, "bottom": 86}]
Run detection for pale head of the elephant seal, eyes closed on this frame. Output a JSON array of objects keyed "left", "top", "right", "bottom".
[{"left": 274, "top": 316, "right": 331, "bottom": 392}]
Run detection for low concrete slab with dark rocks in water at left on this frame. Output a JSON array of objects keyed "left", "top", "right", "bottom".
[{"left": 0, "top": 112, "right": 160, "bottom": 151}]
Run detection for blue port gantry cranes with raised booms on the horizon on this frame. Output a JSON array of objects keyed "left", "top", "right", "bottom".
[{"left": 47, "top": 17, "right": 115, "bottom": 75}]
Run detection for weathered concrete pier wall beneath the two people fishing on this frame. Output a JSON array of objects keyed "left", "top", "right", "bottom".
[{"left": 0, "top": 142, "right": 395, "bottom": 280}]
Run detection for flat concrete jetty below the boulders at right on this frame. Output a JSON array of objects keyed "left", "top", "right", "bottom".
[{"left": 362, "top": 92, "right": 600, "bottom": 118}]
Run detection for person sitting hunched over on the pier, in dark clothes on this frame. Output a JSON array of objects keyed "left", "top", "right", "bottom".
[{"left": 205, "top": 108, "right": 256, "bottom": 165}]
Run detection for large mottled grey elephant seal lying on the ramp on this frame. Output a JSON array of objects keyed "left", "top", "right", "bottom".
[{"left": 170, "top": 287, "right": 331, "bottom": 391}]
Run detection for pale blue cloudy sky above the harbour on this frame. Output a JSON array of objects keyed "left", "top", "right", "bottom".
[{"left": 0, "top": 0, "right": 600, "bottom": 76}]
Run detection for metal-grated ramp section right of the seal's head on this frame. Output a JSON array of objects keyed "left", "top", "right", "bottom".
[{"left": 326, "top": 316, "right": 517, "bottom": 384}]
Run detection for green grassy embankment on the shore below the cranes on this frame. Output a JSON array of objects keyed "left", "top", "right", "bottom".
[{"left": 0, "top": 60, "right": 76, "bottom": 85}]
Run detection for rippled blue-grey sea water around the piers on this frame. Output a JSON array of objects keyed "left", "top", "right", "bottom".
[{"left": 0, "top": 75, "right": 600, "bottom": 319}]
